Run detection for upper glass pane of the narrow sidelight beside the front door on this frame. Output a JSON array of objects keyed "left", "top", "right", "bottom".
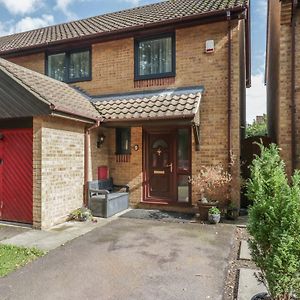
[{"left": 177, "top": 128, "right": 190, "bottom": 171}]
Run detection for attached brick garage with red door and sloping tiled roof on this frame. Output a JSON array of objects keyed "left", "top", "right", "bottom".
[{"left": 0, "top": 58, "right": 100, "bottom": 228}]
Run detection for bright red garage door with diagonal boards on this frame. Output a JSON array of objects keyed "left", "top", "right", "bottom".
[{"left": 0, "top": 129, "right": 33, "bottom": 223}]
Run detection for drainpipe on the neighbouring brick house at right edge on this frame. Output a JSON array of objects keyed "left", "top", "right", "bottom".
[{"left": 291, "top": 0, "right": 297, "bottom": 172}]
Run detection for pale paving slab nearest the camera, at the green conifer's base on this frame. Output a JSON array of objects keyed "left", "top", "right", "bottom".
[{"left": 237, "top": 268, "right": 267, "bottom": 300}]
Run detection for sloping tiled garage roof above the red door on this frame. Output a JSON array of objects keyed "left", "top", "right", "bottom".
[{"left": 0, "top": 58, "right": 99, "bottom": 119}]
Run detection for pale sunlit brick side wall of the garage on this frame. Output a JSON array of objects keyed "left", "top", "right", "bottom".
[{"left": 33, "top": 117, "right": 84, "bottom": 228}]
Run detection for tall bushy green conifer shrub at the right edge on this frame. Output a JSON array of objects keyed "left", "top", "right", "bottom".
[{"left": 247, "top": 144, "right": 300, "bottom": 300}]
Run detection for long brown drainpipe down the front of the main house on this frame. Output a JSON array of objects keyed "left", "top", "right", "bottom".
[{"left": 227, "top": 10, "right": 232, "bottom": 173}]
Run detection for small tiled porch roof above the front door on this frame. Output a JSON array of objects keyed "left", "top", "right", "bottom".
[{"left": 93, "top": 87, "right": 203, "bottom": 122}]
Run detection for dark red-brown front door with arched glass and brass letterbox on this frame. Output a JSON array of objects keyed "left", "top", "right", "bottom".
[{"left": 146, "top": 132, "right": 176, "bottom": 202}]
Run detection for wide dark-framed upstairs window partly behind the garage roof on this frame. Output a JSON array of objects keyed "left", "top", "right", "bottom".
[{"left": 47, "top": 50, "right": 91, "bottom": 82}]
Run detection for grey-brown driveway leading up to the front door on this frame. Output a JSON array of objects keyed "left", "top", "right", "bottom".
[{"left": 0, "top": 218, "right": 234, "bottom": 300}]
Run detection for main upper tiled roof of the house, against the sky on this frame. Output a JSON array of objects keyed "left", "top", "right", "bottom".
[{"left": 0, "top": 0, "right": 248, "bottom": 53}]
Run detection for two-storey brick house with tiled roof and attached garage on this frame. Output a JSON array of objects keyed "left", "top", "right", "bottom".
[{"left": 0, "top": 0, "right": 250, "bottom": 228}]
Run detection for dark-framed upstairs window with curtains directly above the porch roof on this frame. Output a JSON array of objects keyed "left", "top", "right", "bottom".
[{"left": 135, "top": 34, "right": 175, "bottom": 80}]
